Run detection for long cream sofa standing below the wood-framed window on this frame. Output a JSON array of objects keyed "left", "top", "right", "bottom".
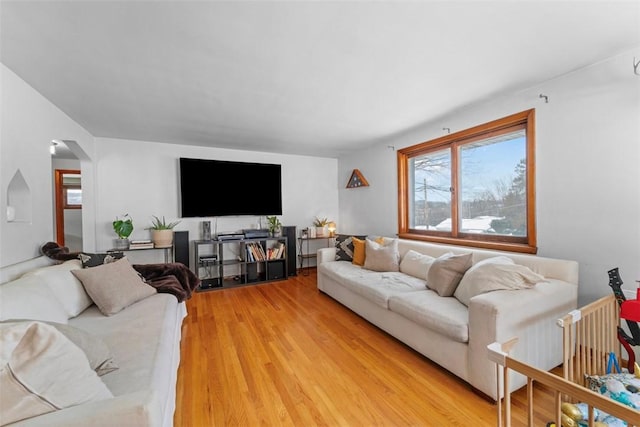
[{"left": 317, "top": 238, "right": 578, "bottom": 400}]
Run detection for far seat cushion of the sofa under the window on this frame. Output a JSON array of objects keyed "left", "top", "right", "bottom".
[{"left": 318, "top": 262, "right": 424, "bottom": 309}]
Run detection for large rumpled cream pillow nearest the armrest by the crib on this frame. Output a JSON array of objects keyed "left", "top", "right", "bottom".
[{"left": 454, "top": 256, "right": 545, "bottom": 306}]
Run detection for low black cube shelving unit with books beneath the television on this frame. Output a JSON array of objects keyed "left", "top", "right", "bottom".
[{"left": 194, "top": 237, "right": 288, "bottom": 291}]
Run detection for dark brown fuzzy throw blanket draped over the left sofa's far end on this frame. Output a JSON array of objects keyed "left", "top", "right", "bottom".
[{"left": 40, "top": 242, "right": 200, "bottom": 302}]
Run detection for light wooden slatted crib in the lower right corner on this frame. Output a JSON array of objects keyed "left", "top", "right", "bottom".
[{"left": 489, "top": 295, "right": 640, "bottom": 427}]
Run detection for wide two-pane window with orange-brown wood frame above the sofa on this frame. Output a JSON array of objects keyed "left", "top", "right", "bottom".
[{"left": 398, "top": 109, "right": 537, "bottom": 253}]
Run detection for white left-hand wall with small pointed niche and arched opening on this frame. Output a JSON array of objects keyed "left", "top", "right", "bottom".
[{"left": 0, "top": 64, "right": 93, "bottom": 267}]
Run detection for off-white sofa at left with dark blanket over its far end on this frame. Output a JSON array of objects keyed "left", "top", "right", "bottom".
[{"left": 0, "top": 259, "right": 186, "bottom": 427}]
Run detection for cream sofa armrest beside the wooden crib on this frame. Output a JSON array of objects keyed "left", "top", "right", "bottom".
[{"left": 469, "top": 279, "right": 578, "bottom": 400}]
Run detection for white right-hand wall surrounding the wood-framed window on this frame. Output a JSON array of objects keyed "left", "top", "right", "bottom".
[{"left": 338, "top": 48, "right": 640, "bottom": 304}]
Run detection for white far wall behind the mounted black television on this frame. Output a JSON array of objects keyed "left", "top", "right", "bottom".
[{"left": 93, "top": 138, "right": 338, "bottom": 262}]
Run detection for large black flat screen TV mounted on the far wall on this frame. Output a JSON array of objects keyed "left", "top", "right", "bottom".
[{"left": 180, "top": 157, "right": 282, "bottom": 218}]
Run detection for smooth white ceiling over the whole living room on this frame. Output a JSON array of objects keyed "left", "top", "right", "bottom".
[{"left": 0, "top": 0, "right": 640, "bottom": 157}]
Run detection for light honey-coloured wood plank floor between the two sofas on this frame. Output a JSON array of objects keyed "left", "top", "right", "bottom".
[{"left": 175, "top": 270, "right": 552, "bottom": 427}]
